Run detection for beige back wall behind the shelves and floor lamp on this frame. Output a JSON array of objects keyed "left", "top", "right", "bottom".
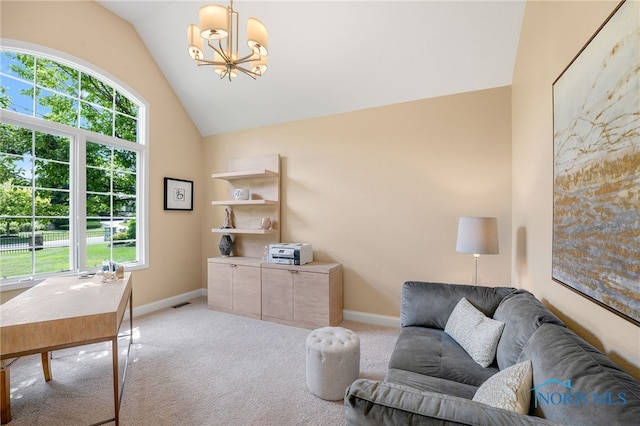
[{"left": 202, "top": 87, "right": 511, "bottom": 316}]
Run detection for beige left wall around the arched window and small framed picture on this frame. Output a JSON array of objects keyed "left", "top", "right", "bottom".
[{"left": 0, "top": 1, "right": 204, "bottom": 305}]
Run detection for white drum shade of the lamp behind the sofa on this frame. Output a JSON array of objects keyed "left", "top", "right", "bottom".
[{"left": 456, "top": 217, "right": 498, "bottom": 254}]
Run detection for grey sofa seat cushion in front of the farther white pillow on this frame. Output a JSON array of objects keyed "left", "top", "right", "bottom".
[{"left": 389, "top": 327, "right": 498, "bottom": 387}]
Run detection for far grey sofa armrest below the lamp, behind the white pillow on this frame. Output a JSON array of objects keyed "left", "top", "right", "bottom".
[{"left": 400, "top": 281, "right": 516, "bottom": 330}]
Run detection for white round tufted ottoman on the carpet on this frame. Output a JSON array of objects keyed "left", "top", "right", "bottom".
[{"left": 307, "top": 327, "right": 360, "bottom": 401}]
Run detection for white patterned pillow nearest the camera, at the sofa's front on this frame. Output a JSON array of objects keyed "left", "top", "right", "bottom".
[{"left": 473, "top": 360, "right": 533, "bottom": 414}]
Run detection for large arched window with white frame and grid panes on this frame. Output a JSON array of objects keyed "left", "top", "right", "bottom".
[{"left": 0, "top": 40, "right": 148, "bottom": 289}]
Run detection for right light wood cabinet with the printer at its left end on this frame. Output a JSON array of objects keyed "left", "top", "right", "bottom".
[{"left": 262, "top": 262, "right": 343, "bottom": 328}]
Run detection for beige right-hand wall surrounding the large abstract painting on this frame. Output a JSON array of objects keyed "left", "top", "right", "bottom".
[{"left": 512, "top": 0, "right": 640, "bottom": 377}]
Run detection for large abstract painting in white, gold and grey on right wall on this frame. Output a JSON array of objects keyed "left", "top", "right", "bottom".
[{"left": 552, "top": 1, "right": 640, "bottom": 325}]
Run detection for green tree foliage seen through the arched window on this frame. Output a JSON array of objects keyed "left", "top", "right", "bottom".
[{"left": 0, "top": 52, "right": 138, "bottom": 230}]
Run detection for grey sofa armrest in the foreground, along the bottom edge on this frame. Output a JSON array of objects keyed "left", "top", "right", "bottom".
[{"left": 344, "top": 379, "right": 557, "bottom": 426}]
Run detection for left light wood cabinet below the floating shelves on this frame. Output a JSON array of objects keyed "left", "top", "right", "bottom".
[{"left": 208, "top": 257, "right": 262, "bottom": 319}]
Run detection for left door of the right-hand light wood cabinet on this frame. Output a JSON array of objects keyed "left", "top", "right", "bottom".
[{"left": 262, "top": 268, "right": 293, "bottom": 321}]
